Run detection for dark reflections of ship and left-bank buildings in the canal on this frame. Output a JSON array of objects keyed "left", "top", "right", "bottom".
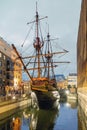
[{"left": 0, "top": 105, "right": 58, "bottom": 130}]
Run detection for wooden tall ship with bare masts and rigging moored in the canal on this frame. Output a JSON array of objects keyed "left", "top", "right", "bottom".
[{"left": 12, "top": 4, "right": 69, "bottom": 108}]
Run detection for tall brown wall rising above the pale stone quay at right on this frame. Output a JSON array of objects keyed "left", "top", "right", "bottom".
[{"left": 77, "top": 0, "right": 87, "bottom": 88}]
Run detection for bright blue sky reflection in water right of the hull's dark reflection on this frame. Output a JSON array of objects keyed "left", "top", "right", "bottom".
[{"left": 54, "top": 101, "right": 78, "bottom": 130}]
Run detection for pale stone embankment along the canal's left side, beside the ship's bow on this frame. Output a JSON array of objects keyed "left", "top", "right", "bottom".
[{"left": 0, "top": 97, "right": 31, "bottom": 120}]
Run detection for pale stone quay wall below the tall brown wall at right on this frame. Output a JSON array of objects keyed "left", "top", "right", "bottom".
[{"left": 78, "top": 87, "right": 87, "bottom": 130}]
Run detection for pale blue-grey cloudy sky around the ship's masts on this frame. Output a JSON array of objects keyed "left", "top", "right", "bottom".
[{"left": 0, "top": 0, "right": 81, "bottom": 76}]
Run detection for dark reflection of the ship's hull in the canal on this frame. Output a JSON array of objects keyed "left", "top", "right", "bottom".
[{"left": 32, "top": 110, "right": 58, "bottom": 130}]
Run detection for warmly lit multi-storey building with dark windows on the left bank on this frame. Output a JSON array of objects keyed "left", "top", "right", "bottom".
[{"left": 0, "top": 37, "right": 22, "bottom": 90}]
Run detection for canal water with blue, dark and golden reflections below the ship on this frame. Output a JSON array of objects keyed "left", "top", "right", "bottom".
[{"left": 0, "top": 101, "right": 79, "bottom": 130}]
